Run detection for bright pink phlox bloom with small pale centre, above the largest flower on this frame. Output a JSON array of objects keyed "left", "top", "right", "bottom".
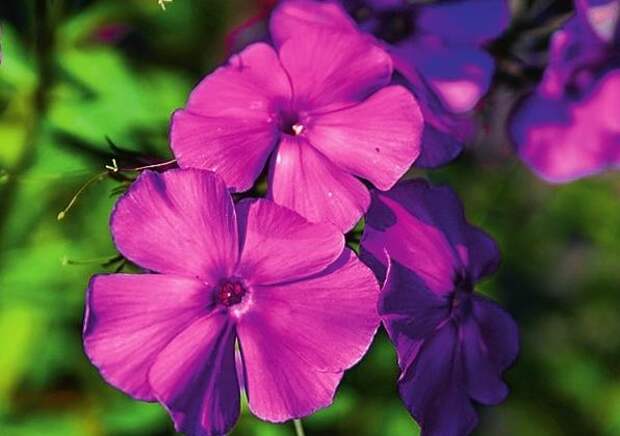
[{"left": 171, "top": 16, "right": 423, "bottom": 231}]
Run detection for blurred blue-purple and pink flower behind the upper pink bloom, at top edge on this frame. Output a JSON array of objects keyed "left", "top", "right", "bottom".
[{"left": 271, "top": 0, "right": 510, "bottom": 167}]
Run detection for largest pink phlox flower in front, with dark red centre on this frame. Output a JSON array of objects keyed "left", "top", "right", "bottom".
[{"left": 84, "top": 169, "right": 379, "bottom": 435}]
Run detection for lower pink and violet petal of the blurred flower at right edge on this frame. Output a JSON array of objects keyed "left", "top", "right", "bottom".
[{"left": 511, "top": 69, "right": 620, "bottom": 183}]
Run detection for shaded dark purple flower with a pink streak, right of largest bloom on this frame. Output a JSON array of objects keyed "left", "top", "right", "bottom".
[{"left": 361, "top": 180, "right": 518, "bottom": 436}]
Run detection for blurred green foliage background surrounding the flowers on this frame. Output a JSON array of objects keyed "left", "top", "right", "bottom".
[{"left": 0, "top": 0, "right": 620, "bottom": 436}]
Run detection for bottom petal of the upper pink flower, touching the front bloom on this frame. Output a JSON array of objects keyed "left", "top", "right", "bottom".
[{"left": 269, "top": 135, "right": 370, "bottom": 232}]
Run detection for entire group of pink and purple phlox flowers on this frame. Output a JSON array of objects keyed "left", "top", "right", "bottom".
[{"left": 84, "top": 0, "right": 620, "bottom": 436}]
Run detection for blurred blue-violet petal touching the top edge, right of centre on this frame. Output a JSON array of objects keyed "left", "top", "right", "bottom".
[{"left": 416, "top": 0, "right": 510, "bottom": 45}]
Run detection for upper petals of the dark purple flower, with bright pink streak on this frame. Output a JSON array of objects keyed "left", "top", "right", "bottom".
[{"left": 362, "top": 179, "right": 499, "bottom": 286}]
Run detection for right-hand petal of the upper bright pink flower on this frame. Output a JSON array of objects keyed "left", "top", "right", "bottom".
[{"left": 308, "top": 86, "right": 423, "bottom": 190}]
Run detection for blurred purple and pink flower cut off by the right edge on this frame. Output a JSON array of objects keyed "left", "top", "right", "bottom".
[{"left": 510, "top": 0, "right": 620, "bottom": 183}]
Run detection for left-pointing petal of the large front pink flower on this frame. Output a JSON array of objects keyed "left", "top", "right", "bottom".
[{"left": 84, "top": 274, "right": 212, "bottom": 401}]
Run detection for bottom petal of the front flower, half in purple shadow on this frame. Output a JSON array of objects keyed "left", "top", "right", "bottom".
[{"left": 149, "top": 312, "right": 240, "bottom": 435}]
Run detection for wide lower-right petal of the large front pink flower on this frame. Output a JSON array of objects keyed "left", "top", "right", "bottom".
[{"left": 247, "top": 249, "right": 379, "bottom": 372}]
